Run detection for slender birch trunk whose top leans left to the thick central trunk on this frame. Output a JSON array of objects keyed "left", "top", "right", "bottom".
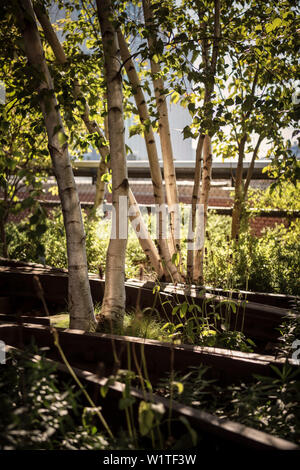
[{"left": 118, "top": 31, "right": 181, "bottom": 282}]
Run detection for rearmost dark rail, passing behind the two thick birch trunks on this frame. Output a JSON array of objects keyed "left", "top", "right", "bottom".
[{"left": 0, "top": 259, "right": 299, "bottom": 350}]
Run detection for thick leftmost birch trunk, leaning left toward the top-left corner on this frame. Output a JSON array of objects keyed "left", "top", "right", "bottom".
[{"left": 19, "top": 0, "right": 95, "bottom": 330}]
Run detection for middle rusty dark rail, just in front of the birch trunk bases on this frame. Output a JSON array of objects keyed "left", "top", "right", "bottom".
[{"left": 0, "top": 323, "right": 296, "bottom": 384}]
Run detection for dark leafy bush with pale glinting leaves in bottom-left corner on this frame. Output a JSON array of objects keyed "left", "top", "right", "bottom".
[{"left": 0, "top": 352, "right": 108, "bottom": 450}]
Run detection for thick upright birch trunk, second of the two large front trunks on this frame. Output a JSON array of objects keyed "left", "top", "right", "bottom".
[{"left": 97, "top": 0, "right": 129, "bottom": 327}]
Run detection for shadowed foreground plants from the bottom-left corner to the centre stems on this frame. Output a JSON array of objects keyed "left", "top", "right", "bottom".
[{"left": 0, "top": 347, "right": 197, "bottom": 450}]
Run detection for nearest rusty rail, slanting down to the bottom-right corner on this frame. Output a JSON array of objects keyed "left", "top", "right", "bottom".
[{"left": 3, "top": 347, "right": 299, "bottom": 451}]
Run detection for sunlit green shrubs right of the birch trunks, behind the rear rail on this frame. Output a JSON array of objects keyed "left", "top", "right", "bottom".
[{"left": 205, "top": 215, "right": 300, "bottom": 295}]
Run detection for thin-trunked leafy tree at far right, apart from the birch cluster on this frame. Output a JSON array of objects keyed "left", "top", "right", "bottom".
[{"left": 217, "top": 2, "right": 297, "bottom": 242}]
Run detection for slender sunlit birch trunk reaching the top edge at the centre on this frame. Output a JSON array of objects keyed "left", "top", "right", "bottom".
[{"left": 143, "top": 0, "right": 180, "bottom": 255}]
